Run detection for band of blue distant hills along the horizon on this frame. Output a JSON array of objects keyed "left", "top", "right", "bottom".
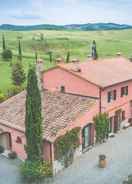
[{"left": 0, "top": 23, "right": 132, "bottom": 31}]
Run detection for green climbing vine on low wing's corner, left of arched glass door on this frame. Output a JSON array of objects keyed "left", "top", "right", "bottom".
[{"left": 55, "top": 128, "right": 80, "bottom": 167}]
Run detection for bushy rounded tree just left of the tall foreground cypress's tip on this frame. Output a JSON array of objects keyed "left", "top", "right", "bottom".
[{"left": 12, "top": 62, "right": 26, "bottom": 86}]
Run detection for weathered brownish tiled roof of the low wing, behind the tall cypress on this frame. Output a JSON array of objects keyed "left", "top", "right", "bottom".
[{"left": 0, "top": 91, "right": 96, "bottom": 141}]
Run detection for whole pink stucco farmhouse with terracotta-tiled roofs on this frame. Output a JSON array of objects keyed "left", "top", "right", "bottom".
[{"left": 0, "top": 56, "right": 132, "bottom": 173}]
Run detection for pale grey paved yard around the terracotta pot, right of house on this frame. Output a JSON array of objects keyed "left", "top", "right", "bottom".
[{"left": 50, "top": 128, "right": 132, "bottom": 184}]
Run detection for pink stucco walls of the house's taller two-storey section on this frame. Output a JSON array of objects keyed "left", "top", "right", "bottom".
[{"left": 43, "top": 68, "right": 132, "bottom": 118}]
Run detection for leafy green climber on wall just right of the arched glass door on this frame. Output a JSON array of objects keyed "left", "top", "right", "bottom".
[{"left": 94, "top": 113, "right": 109, "bottom": 143}]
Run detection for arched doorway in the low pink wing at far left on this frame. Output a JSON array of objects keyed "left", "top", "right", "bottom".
[{"left": 0, "top": 132, "right": 11, "bottom": 150}]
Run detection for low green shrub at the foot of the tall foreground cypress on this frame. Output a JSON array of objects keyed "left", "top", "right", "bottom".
[{"left": 20, "top": 161, "right": 52, "bottom": 182}]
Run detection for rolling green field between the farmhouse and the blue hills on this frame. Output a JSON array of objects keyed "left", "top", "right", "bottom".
[{"left": 0, "top": 30, "right": 132, "bottom": 93}]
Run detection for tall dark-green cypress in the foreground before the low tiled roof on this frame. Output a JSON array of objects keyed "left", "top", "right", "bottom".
[{"left": 25, "top": 68, "right": 43, "bottom": 161}]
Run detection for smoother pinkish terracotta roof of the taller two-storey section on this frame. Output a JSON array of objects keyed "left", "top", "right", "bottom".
[{"left": 58, "top": 57, "right": 132, "bottom": 88}]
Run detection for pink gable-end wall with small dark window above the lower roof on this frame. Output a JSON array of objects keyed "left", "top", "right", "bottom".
[{"left": 43, "top": 68, "right": 99, "bottom": 97}]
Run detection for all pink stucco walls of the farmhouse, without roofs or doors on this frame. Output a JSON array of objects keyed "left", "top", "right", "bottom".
[{"left": 0, "top": 68, "right": 132, "bottom": 161}]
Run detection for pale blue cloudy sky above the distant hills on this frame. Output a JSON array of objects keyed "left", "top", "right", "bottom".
[{"left": 0, "top": 0, "right": 132, "bottom": 25}]
